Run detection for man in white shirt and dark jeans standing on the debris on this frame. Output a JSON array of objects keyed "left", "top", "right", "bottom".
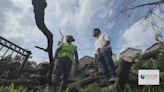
[{"left": 93, "top": 28, "right": 116, "bottom": 82}]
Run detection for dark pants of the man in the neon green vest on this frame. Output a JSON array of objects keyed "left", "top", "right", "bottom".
[{"left": 52, "top": 59, "right": 72, "bottom": 92}]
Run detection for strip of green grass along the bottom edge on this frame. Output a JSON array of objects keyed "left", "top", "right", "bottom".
[{"left": 0, "top": 83, "right": 164, "bottom": 92}]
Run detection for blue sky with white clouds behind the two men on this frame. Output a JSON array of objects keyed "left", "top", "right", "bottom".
[{"left": 0, "top": 0, "right": 164, "bottom": 63}]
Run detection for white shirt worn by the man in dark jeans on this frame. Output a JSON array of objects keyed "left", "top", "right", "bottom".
[{"left": 95, "top": 33, "right": 110, "bottom": 52}]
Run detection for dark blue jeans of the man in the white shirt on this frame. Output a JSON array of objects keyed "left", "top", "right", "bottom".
[{"left": 96, "top": 48, "right": 116, "bottom": 79}]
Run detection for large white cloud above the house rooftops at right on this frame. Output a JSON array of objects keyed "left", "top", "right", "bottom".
[{"left": 120, "top": 15, "right": 164, "bottom": 52}]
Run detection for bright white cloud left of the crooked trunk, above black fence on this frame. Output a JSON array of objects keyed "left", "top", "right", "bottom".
[{"left": 0, "top": 0, "right": 47, "bottom": 63}]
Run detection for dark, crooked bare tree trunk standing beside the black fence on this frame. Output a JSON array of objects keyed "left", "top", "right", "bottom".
[{"left": 32, "top": 0, "right": 54, "bottom": 83}]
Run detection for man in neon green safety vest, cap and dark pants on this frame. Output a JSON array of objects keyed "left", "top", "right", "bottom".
[{"left": 52, "top": 35, "right": 78, "bottom": 92}]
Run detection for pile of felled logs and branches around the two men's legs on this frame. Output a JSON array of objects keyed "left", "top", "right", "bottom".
[{"left": 0, "top": 36, "right": 164, "bottom": 92}]
